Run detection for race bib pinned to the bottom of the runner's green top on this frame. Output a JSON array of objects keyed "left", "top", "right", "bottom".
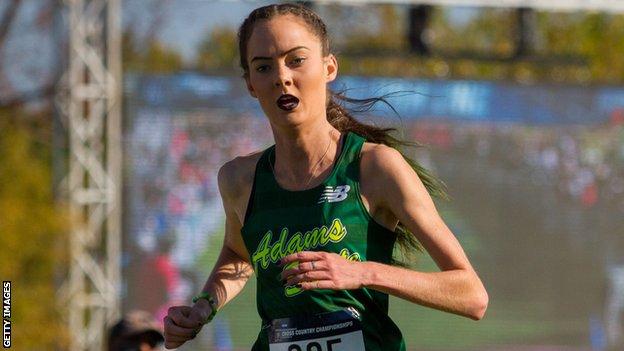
[{"left": 269, "top": 308, "right": 364, "bottom": 351}]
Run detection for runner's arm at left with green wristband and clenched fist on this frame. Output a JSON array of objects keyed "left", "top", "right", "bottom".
[{"left": 164, "top": 161, "right": 253, "bottom": 349}]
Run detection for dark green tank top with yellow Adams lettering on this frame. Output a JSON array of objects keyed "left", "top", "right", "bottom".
[{"left": 241, "top": 132, "right": 405, "bottom": 351}]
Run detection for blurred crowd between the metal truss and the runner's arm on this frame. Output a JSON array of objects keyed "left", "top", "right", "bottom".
[{"left": 124, "top": 110, "right": 272, "bottom": 350}]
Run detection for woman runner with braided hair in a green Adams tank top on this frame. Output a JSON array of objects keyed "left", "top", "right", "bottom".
[{"left": 164, "top": 4, "right": 488, "bottom": 351}]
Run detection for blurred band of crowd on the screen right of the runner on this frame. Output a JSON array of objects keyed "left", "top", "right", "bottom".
[{"left": 411, "top": 121, "right": 624, "bottom": 211}]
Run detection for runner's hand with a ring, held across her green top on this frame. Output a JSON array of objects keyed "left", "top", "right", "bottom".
[{"left": 280, "top": 251, "right": 365, "bottom": 290}]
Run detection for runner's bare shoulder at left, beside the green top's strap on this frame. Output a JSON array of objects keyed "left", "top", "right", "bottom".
[{"left": 218, "top": 150, "right": 263, "bottom": 223}]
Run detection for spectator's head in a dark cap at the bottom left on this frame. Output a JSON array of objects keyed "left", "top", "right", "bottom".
[{"left": 108, "top": 310, "right": 165, "bottom": 351}]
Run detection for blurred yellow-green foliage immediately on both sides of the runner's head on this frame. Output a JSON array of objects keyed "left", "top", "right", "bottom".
[{"left": 190, "top": 4, "right": 624, "bottom": 84}]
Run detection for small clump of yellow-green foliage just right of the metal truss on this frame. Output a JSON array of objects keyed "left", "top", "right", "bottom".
[{"left": 122, "top": 30, "right": 183, "bottom": 73}]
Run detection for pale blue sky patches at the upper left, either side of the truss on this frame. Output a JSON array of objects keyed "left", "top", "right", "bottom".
[{"left": 0, "top": 0, "right": 270, "bottom": 96}]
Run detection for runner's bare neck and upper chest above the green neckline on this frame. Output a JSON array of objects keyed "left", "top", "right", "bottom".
[{"left": 273, "top": 120, "right": 341, "bottom": 190}]
